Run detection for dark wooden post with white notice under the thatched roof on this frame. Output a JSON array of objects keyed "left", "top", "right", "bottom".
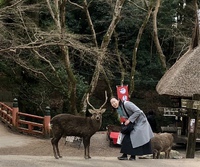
[{"left": 186, "top": 95, "right": 200, "bottom": 158}]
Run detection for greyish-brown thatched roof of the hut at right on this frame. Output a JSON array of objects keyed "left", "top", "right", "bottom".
[{"left": 156, "top": 46, "right": 200, "bottom": 97}]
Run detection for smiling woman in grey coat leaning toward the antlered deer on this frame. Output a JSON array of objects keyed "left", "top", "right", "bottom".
[{"left": 110, "top": 97, "right": 153, "bottom": 160}]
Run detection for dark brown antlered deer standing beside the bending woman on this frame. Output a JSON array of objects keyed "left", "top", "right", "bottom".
[{"left": 51, "top": 92, "right": 108, "bottom": 159}]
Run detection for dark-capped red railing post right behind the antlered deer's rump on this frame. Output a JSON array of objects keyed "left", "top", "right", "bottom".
[{"left": 44, "top": 106, "right": 51, "bottom": 138}]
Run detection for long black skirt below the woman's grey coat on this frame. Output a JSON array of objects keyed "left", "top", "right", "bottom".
[{"left": 120, "top": 135, "right": 152, "bottom": 155}]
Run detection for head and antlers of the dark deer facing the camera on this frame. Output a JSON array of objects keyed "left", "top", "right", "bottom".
[{"left": 87, "top": 91, "right": 108, "bottom": 120}]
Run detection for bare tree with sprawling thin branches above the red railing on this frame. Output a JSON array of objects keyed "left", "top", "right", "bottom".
[{"left": 0, "top": 0, "right": 99, "bottom": 114}]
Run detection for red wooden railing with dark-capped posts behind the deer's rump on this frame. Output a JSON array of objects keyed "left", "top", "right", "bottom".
[{"left": 0, "top": 99, "right": 51, "bottom": 137}]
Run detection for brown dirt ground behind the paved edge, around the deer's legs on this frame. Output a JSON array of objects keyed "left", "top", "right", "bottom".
[{"left": 0, "top": 122, "right": 200, "bottom": 158}]
